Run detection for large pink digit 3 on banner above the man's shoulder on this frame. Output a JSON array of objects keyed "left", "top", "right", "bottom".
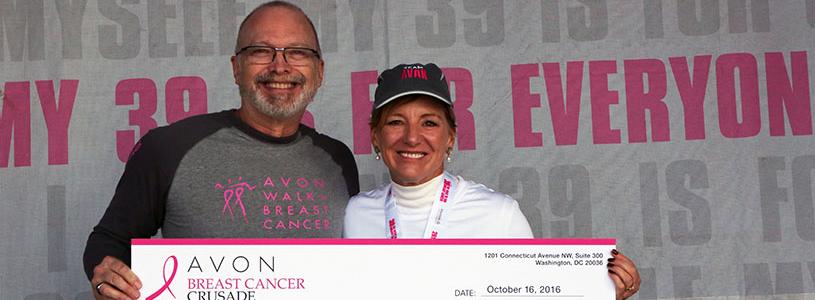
[{"left": 116, "top": 78, "right": 158, "bottom": 162}]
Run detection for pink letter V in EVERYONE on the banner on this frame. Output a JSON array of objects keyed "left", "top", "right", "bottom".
[{"left": 543, "top": 61, "right": 583, "bottom": 146}]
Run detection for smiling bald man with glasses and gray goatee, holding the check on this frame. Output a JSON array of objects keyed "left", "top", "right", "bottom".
[{"left": 84, "top": 1, "right": 359, "bottom": 299}]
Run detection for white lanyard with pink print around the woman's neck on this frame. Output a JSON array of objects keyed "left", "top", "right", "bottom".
[{"left": 385, "top": 172, "right": 457, "bottom": 239}]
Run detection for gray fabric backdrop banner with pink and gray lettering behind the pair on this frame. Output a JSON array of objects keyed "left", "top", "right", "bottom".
[{"left": 0, "top": 0, "right": 815, "bottom": 299}]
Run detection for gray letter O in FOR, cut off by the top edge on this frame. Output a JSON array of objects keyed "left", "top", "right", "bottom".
[{"left": 676, "top": 0, "right": 719, "bottom": 36}]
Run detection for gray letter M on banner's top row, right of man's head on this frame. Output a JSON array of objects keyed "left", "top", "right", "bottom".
[{"left": 291, "top": 0, "right": 338, "bottom": 52}]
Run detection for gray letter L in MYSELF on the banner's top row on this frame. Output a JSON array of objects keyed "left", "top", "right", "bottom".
[{"left": 183, "top": 0, "right": 215, "bottom": 56}]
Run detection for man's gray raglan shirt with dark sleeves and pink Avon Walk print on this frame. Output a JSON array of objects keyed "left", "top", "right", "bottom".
[{"left": 84, "top": 110, "right": 359, "bottom": 278}]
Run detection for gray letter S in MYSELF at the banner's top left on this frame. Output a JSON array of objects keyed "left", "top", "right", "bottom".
[{"left": 96, "top": 0, "right": 141, "bottom": 59}]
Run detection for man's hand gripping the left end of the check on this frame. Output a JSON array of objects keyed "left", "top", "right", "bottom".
[{"left": 91, "top": 256, "right": 141, "bottom": 300}]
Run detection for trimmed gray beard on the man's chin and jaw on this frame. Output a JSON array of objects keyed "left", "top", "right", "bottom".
[{"left": 238, "top": 78, "right": 317, "bottom": 118}]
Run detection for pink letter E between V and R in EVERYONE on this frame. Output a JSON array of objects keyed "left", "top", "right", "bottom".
[{"left": 589, "top": 60, "right": 621, "bottom": 144}]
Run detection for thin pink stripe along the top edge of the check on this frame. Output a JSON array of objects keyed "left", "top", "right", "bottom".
[{"left": 131, "top": 239, "right": 617, "bottom": 245}]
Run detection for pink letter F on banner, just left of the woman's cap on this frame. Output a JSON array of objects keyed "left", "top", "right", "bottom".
[{"left": 351, "top": 71, "right": 379, "bottom": 154}]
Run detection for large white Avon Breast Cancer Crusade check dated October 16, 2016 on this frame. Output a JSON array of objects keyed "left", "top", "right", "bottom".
[{"left": 132, "top": 239, "right": 615, "bottom": 300}]
